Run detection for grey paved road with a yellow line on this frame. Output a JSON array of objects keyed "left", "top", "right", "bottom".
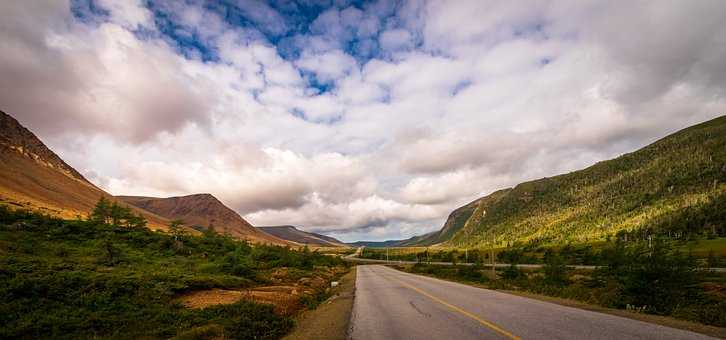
[{"left": 349, "top": 265, "right": 710, "bottom": 340}]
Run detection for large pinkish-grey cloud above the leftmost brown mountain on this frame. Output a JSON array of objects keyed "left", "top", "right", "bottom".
[{"left": 0, "top": 0, "right": 213, "bottom": 143}]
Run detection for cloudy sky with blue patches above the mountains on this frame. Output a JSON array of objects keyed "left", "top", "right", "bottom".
[{"left": 0, "top": 0, "right": 726, "bottom": 241}]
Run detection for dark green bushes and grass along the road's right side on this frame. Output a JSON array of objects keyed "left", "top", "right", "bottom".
[{"left": 401, "top": 239, "right": 726, "bottom": 327}]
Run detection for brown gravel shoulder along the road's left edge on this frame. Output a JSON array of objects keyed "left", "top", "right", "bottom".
[{"left": 283, "top": 267, "right": 357, "bottom": 340}]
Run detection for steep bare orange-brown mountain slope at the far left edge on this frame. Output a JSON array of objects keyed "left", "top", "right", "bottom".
[{"left": 0, "top": 111, "right": 168, "bottom": 228}]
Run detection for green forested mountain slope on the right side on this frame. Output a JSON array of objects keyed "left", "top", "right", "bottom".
[{"left": 410, "top": 116, "right": 726, "bottom": 246}]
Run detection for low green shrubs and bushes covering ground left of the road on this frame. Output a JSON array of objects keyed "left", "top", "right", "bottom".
[{"left": 0, "top": 201, "right": 346, "bottom": 339}]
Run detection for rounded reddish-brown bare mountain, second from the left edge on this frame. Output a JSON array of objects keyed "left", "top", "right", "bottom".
[{"left": 116, "top": 194, "right": 290, "bottom": 245}]
